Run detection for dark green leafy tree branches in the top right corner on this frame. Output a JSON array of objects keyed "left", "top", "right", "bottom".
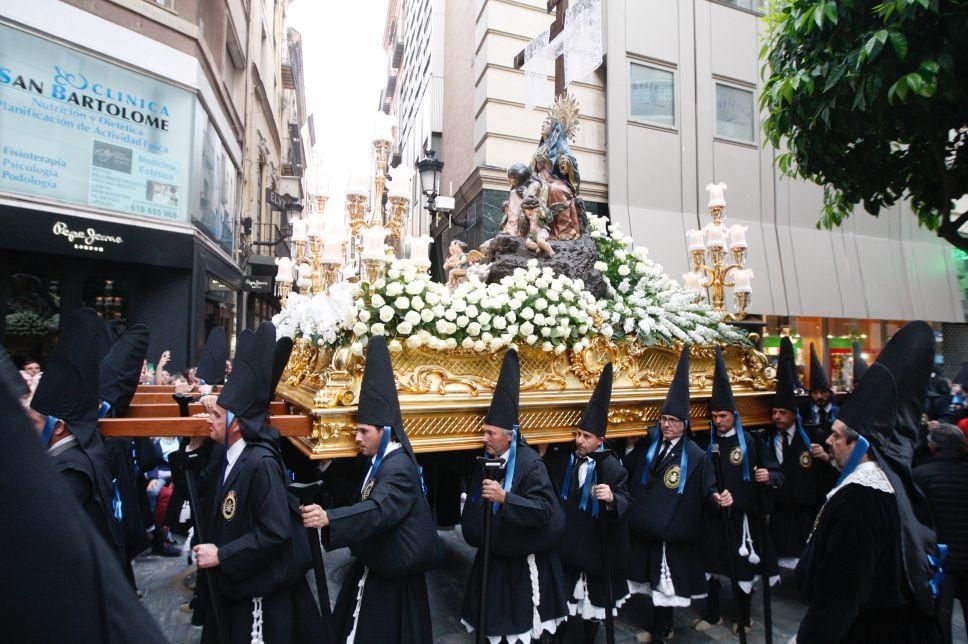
[{"left": 760, "top": 0, "right": 968, "bottom": 249}]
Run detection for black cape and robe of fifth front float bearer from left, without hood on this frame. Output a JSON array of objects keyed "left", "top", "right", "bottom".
[{"left": 629, "top": 430, "right": 716, "bottom": 605}]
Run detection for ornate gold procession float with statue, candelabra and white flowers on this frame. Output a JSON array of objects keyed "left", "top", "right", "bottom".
[{"left": 262, "top": 95, "right": 774, "bottom": 459}]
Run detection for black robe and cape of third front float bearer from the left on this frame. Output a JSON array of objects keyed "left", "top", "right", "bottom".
[{"left": 461, "top": 444, "right": 571, "bottom": 636}]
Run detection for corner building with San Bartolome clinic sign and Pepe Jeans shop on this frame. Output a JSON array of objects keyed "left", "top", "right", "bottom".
[{"left": 0, "top": 0, "right": 302, "bottom": 371}]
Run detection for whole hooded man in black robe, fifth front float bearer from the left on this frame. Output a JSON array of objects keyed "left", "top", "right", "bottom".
[{"left": 629, "top": 345, "right": 716, "bottom": 642}]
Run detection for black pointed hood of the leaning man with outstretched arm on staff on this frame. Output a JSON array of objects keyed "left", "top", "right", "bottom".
[{"left": 356, "top": 335, "right": 416, "bottom": 462}]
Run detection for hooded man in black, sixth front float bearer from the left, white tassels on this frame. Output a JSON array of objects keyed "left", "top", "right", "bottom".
[{"left": 694, "top": 347, "right": 783, "bottom": 632}]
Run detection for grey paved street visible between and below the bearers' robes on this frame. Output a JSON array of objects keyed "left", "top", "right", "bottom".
[{"left": 135, "top": 530, "right": 968, "bottom": 644}]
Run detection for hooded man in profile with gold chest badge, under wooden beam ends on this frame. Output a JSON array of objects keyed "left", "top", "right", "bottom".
[{"left": 193, "top": 323, "right": 322, "bottom": 643}]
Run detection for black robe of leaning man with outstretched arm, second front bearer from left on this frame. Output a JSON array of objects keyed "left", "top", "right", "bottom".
[{"left": 323, "top": 447, "right": 443, "bottom": 644}]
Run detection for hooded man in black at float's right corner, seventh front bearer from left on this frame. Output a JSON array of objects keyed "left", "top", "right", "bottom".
[{"left": 767, "top": 337, "right": 837, "bottom": 568}]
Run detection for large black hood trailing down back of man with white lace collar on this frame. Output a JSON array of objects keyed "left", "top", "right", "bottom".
[{"left": 837, "top": 321, "right": 936, "bottom": 612}]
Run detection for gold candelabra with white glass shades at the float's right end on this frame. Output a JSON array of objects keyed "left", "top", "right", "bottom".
[{"left": 683, "top": 189, "right": 753, "bottom": 321}]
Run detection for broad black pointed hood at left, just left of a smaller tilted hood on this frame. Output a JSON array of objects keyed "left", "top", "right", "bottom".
[{"left": 30, "top": 308, "right": 104, "bottom": 438}]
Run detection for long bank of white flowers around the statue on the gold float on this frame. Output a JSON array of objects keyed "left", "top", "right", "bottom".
[{"left": 273, "top": 223, "right": 745, "bottom": 355}]
